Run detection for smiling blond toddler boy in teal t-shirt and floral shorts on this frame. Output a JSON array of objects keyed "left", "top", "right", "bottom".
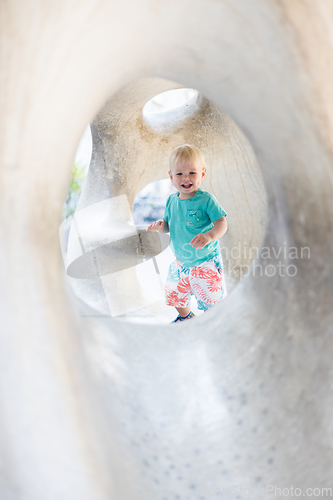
[{"left": 147, "top": 144, "right": 227, "bottom": 323}]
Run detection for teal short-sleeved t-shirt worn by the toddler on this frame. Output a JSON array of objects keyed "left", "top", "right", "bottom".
[{"left": 164, "top": 189, "right": 227, "bottom": 267}]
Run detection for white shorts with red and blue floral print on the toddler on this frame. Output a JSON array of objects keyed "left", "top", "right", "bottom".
[{"left": 164, "top": 255, "right": 227, "bottom": 311}]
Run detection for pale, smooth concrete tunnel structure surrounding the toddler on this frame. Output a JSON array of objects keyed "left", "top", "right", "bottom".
[{"left": 0, "top": 0, "right": 333, "bottom": 500}]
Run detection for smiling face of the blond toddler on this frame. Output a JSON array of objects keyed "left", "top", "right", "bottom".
[{"left": 169, "top": 160, "right": 206, "bottom": 200}]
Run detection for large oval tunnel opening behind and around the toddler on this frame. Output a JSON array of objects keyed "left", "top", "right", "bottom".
[{"left": 59, "top": 78, "right": 267, "bottom": 324}]
